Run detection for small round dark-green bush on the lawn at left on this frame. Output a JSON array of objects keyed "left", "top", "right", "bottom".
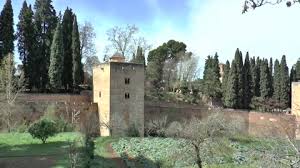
[{"left": 28, "top": 119, "right": 57, "bottom": 144}]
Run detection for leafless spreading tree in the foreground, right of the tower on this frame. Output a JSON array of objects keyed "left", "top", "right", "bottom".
[{"left": 168, "top": 112, "right": 238, "bottom": 168}]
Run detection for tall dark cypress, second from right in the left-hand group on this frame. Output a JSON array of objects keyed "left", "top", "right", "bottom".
[{"left": 62, "top": 8, "right": 74, "bottom": 90}]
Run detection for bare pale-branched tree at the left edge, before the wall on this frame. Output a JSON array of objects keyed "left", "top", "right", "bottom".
[{"left": 0, "top": 53, "right": 25, "bottom": 132}]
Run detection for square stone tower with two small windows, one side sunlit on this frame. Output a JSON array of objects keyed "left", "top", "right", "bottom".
[{"left": 93, "top": 54, "right": 145, "bottom": 136}]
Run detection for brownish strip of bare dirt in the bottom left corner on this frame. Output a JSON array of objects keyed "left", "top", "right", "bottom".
[{"left": 0, "top": 156, "right": 55, "bottom": 168}]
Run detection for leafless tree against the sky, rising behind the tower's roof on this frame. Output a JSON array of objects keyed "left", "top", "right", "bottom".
[{"left": 105, "top": 25, "right": 151, "bottom": 59}]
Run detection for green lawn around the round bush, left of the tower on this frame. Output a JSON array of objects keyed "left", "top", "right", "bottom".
[{"left": 0, "top": 132, "right": 82, "bottom": 168}]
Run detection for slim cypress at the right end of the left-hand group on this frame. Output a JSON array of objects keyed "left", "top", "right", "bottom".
[{"left": 72, "top": 15, "right": 83, "bottom": 88}]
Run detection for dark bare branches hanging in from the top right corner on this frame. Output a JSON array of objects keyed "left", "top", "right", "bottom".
[{"left": 242, "top": 0, "right": 300, "bottom": 13}]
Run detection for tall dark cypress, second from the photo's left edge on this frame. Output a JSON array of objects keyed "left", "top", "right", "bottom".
[{"left": 17, "top": 1, "right": 36, "bottom": 88}]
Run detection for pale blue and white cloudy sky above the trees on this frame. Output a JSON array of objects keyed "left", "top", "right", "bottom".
[{"left": 0, "top": 0, "right": 300, "bottom": 70}]
